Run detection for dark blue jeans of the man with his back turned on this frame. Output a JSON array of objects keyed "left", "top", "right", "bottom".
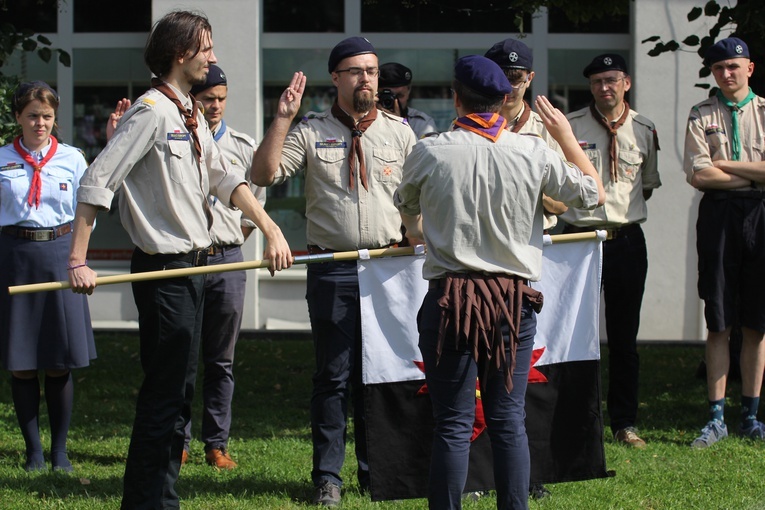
[{"left": 419, "top": 289, "right": 537, "bottom": 510}]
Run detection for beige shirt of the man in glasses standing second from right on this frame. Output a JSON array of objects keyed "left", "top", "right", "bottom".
[{"left": 560, "top": 108, "right": 661, "bottom": 227}]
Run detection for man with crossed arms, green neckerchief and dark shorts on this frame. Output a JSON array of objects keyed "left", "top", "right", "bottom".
[{"left": 683, "top": 37, "right": 765, "bottom": 448}]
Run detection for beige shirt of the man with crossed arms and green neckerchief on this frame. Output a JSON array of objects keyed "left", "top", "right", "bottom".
[{"left": 683, "top": 92, "right": 765, "bottom": 189}]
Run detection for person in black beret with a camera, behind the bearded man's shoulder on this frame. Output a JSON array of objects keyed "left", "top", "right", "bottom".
[{"left": 377, "top": 62, "right": 438, "bottom": 139}]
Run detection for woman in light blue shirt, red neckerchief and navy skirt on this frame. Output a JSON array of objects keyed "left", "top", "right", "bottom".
[{"left": 0, "top": 81, "right": 96, "bottom": 472}]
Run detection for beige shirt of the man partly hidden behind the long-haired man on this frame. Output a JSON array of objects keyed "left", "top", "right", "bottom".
[{"left": 208, "top": 123, "right": 266, "bottom": 246}]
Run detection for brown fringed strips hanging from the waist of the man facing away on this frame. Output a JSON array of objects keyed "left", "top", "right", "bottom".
[{"left": 436, "top": 273, "right": 543, "bottom": 393}]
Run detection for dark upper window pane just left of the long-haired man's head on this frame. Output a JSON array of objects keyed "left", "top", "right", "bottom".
[{"left": 74, "top": 0, "right": 151, "bottom": 32}]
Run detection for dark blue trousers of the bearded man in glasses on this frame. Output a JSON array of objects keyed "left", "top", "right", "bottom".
[{"left": 306, "top": 261, "right": 369, "bottom": 488}]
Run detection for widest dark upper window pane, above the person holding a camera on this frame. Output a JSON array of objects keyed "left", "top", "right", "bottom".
[{"left": 361, "top": 0, "right": 531, "bottom": 33}]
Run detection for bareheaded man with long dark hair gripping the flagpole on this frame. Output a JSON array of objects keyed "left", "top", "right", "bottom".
[{"left": 69, "top": 11, "right": 292, "bottom": 509}]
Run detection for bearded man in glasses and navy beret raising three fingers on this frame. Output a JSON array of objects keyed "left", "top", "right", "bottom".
[{"left": 253, "top": 37, "right": 417, "bottom": 506}]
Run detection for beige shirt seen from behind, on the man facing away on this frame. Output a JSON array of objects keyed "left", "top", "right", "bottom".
[{"left": 394, "top": 129, "right": 598, "bottom": 280}]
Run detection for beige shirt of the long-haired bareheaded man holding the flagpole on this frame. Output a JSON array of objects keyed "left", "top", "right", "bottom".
[{"left": 77, "top": 85, "right": 246, "bottom": 254}]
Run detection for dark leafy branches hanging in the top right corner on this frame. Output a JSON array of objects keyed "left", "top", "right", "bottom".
[{"left": 642, "top": 0, "right": 765, "bottom": 96}]
